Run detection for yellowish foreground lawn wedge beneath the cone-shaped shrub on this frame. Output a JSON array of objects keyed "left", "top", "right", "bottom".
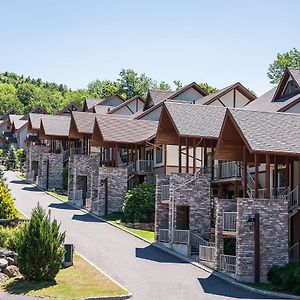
[{"left": 0, "top": 253, "right": 127, "bottom": 300}]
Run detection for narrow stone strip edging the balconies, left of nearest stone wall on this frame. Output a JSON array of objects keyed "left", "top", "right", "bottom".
[{"left": 214, "top": 199, "right": 237, "bottom": 269}]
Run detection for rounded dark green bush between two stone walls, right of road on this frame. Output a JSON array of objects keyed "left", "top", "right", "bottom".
[{"left": 123, "top": 182, "right": 155, "bottom": 223}]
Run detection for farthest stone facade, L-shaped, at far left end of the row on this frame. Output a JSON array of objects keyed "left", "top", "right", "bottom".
[{"left": 26, "top": 145, "right": 50, "bottom": 180}]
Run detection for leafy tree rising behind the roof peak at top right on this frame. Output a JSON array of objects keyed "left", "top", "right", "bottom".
[{"left": 267, "top": 48, "right": 300, "bottom": 84}]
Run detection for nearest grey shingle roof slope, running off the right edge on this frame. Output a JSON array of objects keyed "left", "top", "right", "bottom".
[{"left": 229, "top": 109, "right": 300, "bottom": 154}]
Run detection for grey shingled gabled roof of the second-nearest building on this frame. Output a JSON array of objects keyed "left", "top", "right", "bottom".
[{"left": 159, "top": 101, "right": 226, "bottom": 139}]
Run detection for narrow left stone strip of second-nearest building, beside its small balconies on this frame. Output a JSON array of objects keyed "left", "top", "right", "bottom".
[{"left": 154, "top": 175, "right": 170, "bottom": 241}]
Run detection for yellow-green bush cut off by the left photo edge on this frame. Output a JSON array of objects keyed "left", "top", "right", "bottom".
[{"left": 0, "top": 180, "right": 17, "bottom": 219}]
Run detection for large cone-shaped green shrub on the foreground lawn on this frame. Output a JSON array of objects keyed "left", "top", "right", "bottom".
[{"left": 16, "top": 204, "right": 65, "bottom": 282}]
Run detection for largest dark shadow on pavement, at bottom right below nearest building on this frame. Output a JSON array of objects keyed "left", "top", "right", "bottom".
[{"left": 198, "top": 274, "right": 279, "bottom": 299}]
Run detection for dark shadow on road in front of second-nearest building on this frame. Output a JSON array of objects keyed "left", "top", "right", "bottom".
[{"left": 135, "top": 245, "right": 186, "bottom": 264}]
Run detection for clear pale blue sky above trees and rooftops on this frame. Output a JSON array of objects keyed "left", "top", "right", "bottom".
[{"left": 0, "top": 0, "right": 300, "bottom": 94}]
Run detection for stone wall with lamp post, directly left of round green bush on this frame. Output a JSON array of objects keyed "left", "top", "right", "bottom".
[{"left": 92, "top": 167, "right": 128, "bottom": 216}]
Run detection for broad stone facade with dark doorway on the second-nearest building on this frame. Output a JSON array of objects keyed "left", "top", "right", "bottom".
[{"left": 155, "top": 172, "right": 211, "bottom": 243}]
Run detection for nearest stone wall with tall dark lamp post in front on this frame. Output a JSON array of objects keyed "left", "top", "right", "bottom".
[{"left": 236, "top": 198, "right": 288, "bottom": 281}]
